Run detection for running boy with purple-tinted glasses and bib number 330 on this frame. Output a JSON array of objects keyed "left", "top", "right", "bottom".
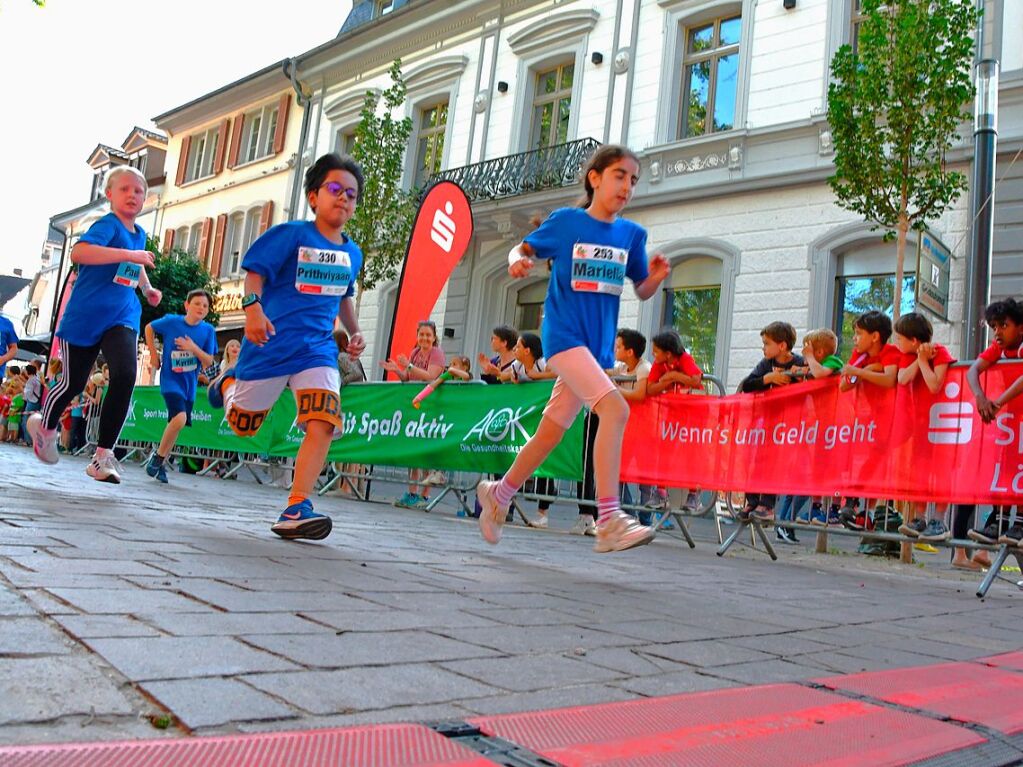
[{"left": 209, "top": 154, "right": 365, "bottom": 540}]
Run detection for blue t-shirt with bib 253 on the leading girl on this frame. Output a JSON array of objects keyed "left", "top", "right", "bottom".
[{"left": 525, "top": 208, "right": 648, "bottom": 369}]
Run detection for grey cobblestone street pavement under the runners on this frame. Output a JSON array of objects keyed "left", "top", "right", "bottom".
[{"left": 0, "top": 445, "right": 1023, "bottom": 743}]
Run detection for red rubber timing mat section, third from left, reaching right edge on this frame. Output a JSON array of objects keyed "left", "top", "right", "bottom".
[{"left": 816, "top": 663, "right": 1023, "bottom": 735}]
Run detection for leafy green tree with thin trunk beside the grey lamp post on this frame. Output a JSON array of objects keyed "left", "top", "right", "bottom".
[{"left": 828, "top": 0, "right": 978, "bottom": 318}]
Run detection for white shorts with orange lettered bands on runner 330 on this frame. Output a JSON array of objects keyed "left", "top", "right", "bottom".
[{"left": 223, "top": 366, "right": 342, "bottom": 440}]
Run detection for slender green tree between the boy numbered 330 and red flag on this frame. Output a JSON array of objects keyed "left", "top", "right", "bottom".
[{"left": 345, "top": 59, "right": 418, "bottom": 307}]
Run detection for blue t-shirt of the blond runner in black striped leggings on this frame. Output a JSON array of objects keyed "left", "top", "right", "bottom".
[{"left": 57, "top": 213, "right": 145, "bottom": 347}]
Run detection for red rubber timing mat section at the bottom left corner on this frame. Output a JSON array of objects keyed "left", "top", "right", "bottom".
[{"left": 0, "top": 724, "right": 494, "bottom": 767}]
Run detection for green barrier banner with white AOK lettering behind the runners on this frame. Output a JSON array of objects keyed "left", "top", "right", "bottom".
[{"left": 121, "top": 381, "right": 583, "bottom": 480}]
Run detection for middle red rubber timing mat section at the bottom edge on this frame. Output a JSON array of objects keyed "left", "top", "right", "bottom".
[{"left": 470, "top": 684, "right": 985, "bottom": 767}]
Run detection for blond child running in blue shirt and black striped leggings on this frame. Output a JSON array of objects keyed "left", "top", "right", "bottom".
[{"left": 28, "top": 166, "right": 162, "bottom": 484}]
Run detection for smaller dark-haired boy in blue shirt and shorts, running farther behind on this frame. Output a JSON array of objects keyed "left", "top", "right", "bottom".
[{"left": 145, "top": 288, "right": 217, "bottom": 484}]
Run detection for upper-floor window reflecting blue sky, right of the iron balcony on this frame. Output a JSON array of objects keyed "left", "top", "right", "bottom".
[{"left": 678, "top": 15, "right": 743, "bottom": 138}]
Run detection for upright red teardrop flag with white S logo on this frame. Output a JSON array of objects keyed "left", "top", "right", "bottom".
[{"left": 388, "top": 181, "right": 473, "bottom": 378}]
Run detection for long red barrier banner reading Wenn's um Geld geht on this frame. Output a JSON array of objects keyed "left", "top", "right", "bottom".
[{"left": 622, "top": 362, "right": 1023, "bottom": 503}]
